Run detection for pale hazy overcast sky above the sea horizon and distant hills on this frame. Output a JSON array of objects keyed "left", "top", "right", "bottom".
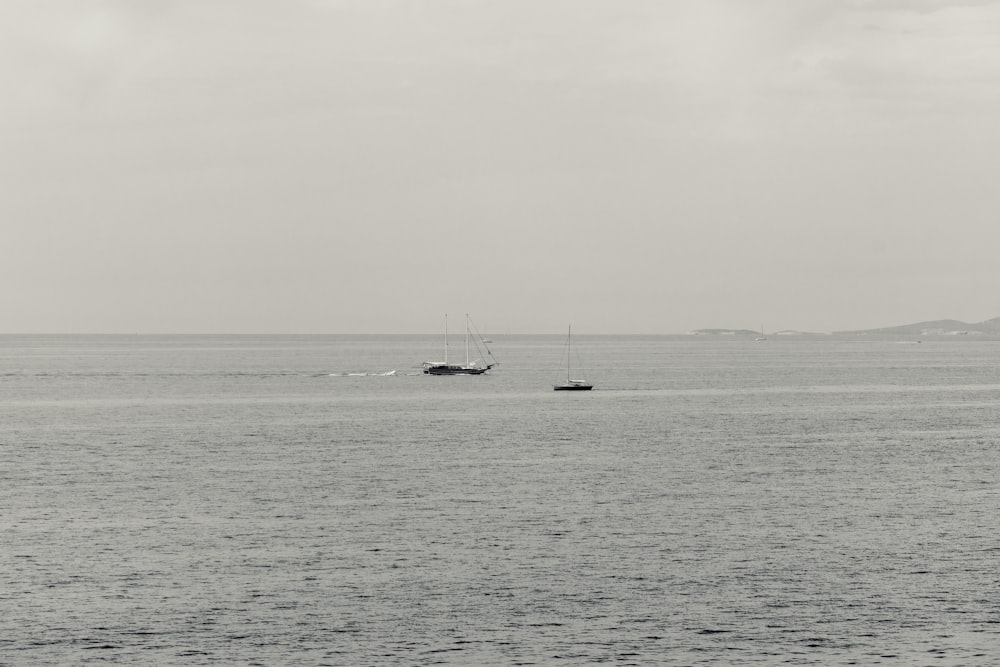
[{"left": 0, "top": 0, "right": 1000, "bottom": 333}]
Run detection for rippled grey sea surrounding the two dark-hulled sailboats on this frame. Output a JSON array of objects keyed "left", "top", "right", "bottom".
[{"left": 0, "top": 335, "right": 1000, "bottom": 666}]
